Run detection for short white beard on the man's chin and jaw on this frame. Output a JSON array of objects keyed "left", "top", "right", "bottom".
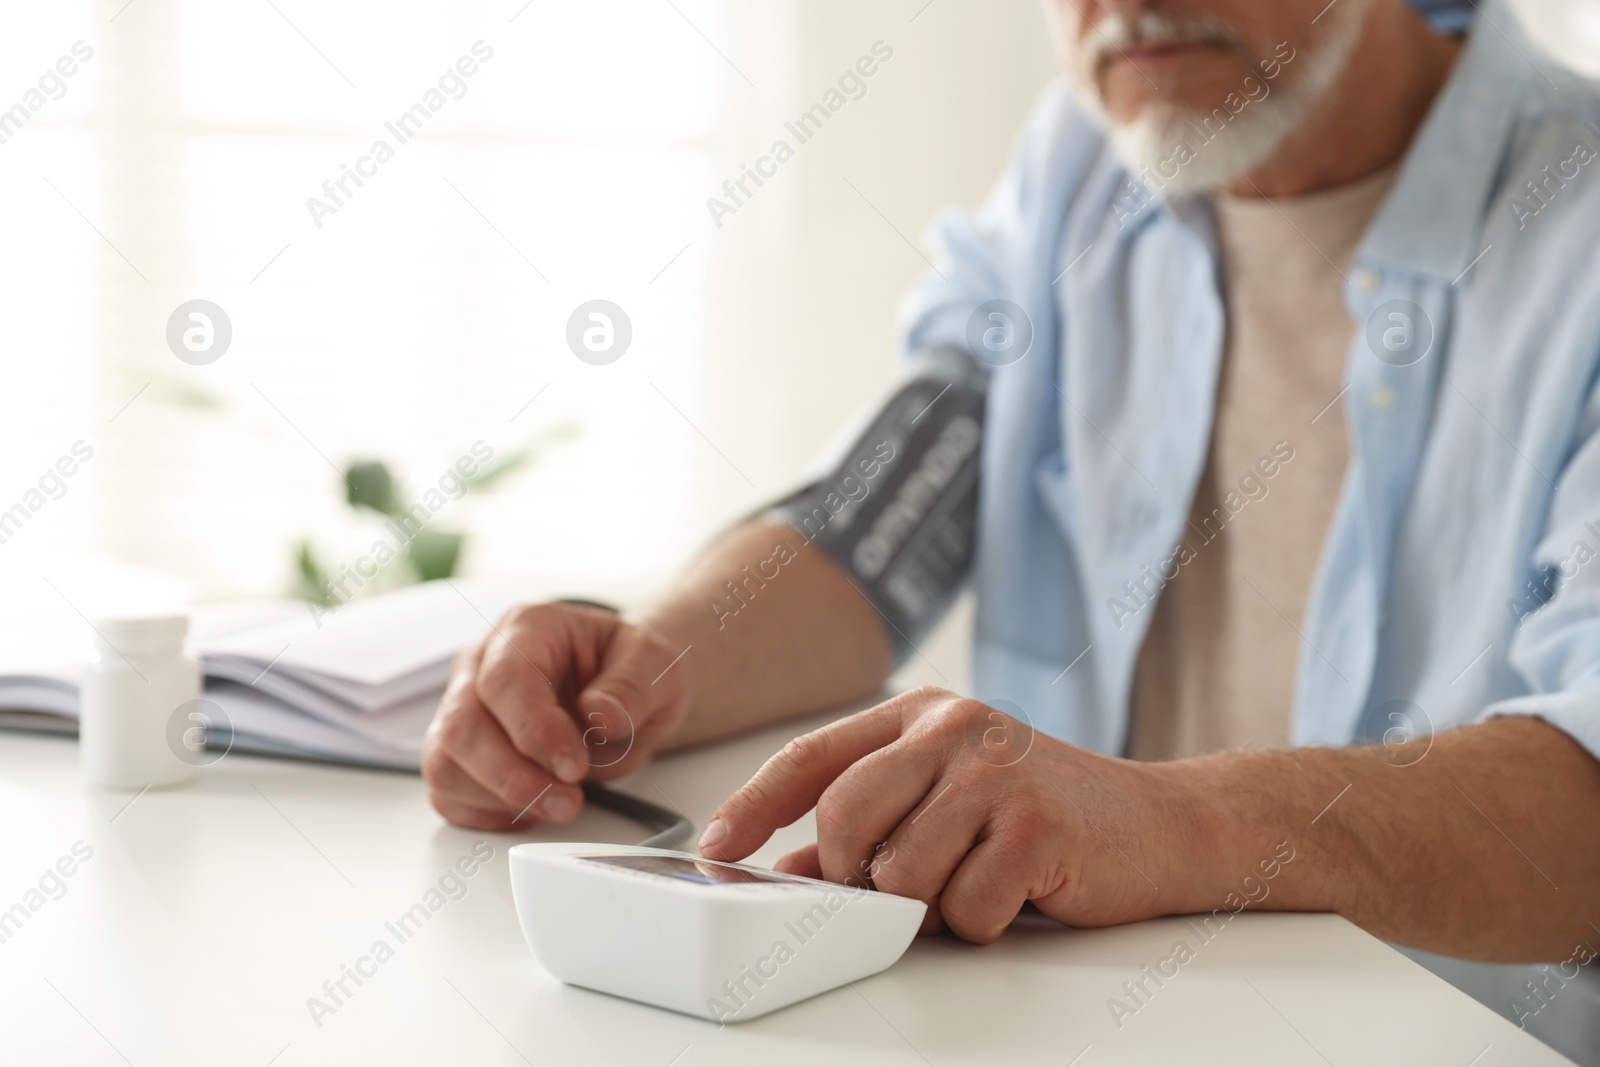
[{"left": 1074, "top": 0, "right": 1370, "bottom": 197}]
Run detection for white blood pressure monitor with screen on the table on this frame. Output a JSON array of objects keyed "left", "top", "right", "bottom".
[{"left": 510, "top": 841, "right": 926, "bottom": 1022}]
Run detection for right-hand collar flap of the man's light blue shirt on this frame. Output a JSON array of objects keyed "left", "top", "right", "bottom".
[{"left": 1357, "top": 0, "right": 1554, "bottom": 280}]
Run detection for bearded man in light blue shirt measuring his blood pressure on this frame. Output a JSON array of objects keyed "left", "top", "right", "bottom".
[{"left": 424, "top": 0, "right": 1600, "bottom": 963}]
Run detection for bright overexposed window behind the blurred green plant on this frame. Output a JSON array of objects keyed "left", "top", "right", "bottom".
[{"left": 0, "top": 0, "right": 778, "bottom": 595}]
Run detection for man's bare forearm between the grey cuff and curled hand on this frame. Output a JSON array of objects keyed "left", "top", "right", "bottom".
[{"left": 638, "top": 518, "right": 891, "bottom": 749}]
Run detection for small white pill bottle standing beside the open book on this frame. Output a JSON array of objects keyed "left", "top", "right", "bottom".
[{"left": 78, "top": 608, "right": 202, "bottom": 789}]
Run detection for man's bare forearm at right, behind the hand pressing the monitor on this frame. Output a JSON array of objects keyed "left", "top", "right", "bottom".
[{"left": 1163, "top": 717, "right": 1600, "bottom": 961}]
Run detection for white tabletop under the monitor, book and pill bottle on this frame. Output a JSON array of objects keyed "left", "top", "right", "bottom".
[{"left": 0, "top": 713, "right": 1566, "bottom": 1067}]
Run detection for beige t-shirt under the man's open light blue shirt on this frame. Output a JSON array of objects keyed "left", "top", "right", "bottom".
[{"left": 1128, "top": 168, "right": 1395, "bottom": 760}]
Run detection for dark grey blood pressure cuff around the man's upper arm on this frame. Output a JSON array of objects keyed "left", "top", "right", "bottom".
[{"left": 768, "top": 349, "right": 987, "bottom": 662}]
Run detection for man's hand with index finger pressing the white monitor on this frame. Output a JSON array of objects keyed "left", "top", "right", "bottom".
[{"left": 701, "top": 688, "right": 1210, "bottom": 942}]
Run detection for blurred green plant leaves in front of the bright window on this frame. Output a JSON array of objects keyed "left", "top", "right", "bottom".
[{"left": 291, "top": 424, "right": 576, "bottom": 606}]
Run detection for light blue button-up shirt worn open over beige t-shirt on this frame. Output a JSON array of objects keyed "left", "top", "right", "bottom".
[{"left": 904, "top": 0, "right": 1600, "bottom": 755}]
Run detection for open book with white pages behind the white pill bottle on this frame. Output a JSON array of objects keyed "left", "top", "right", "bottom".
[{"left": 0, "top": 581, "right": 522, "bottom": 771}]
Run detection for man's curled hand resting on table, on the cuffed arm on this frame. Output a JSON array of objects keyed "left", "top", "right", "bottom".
[{"left": 422, "top": 603, "right": 690, "bottom": 830}]
